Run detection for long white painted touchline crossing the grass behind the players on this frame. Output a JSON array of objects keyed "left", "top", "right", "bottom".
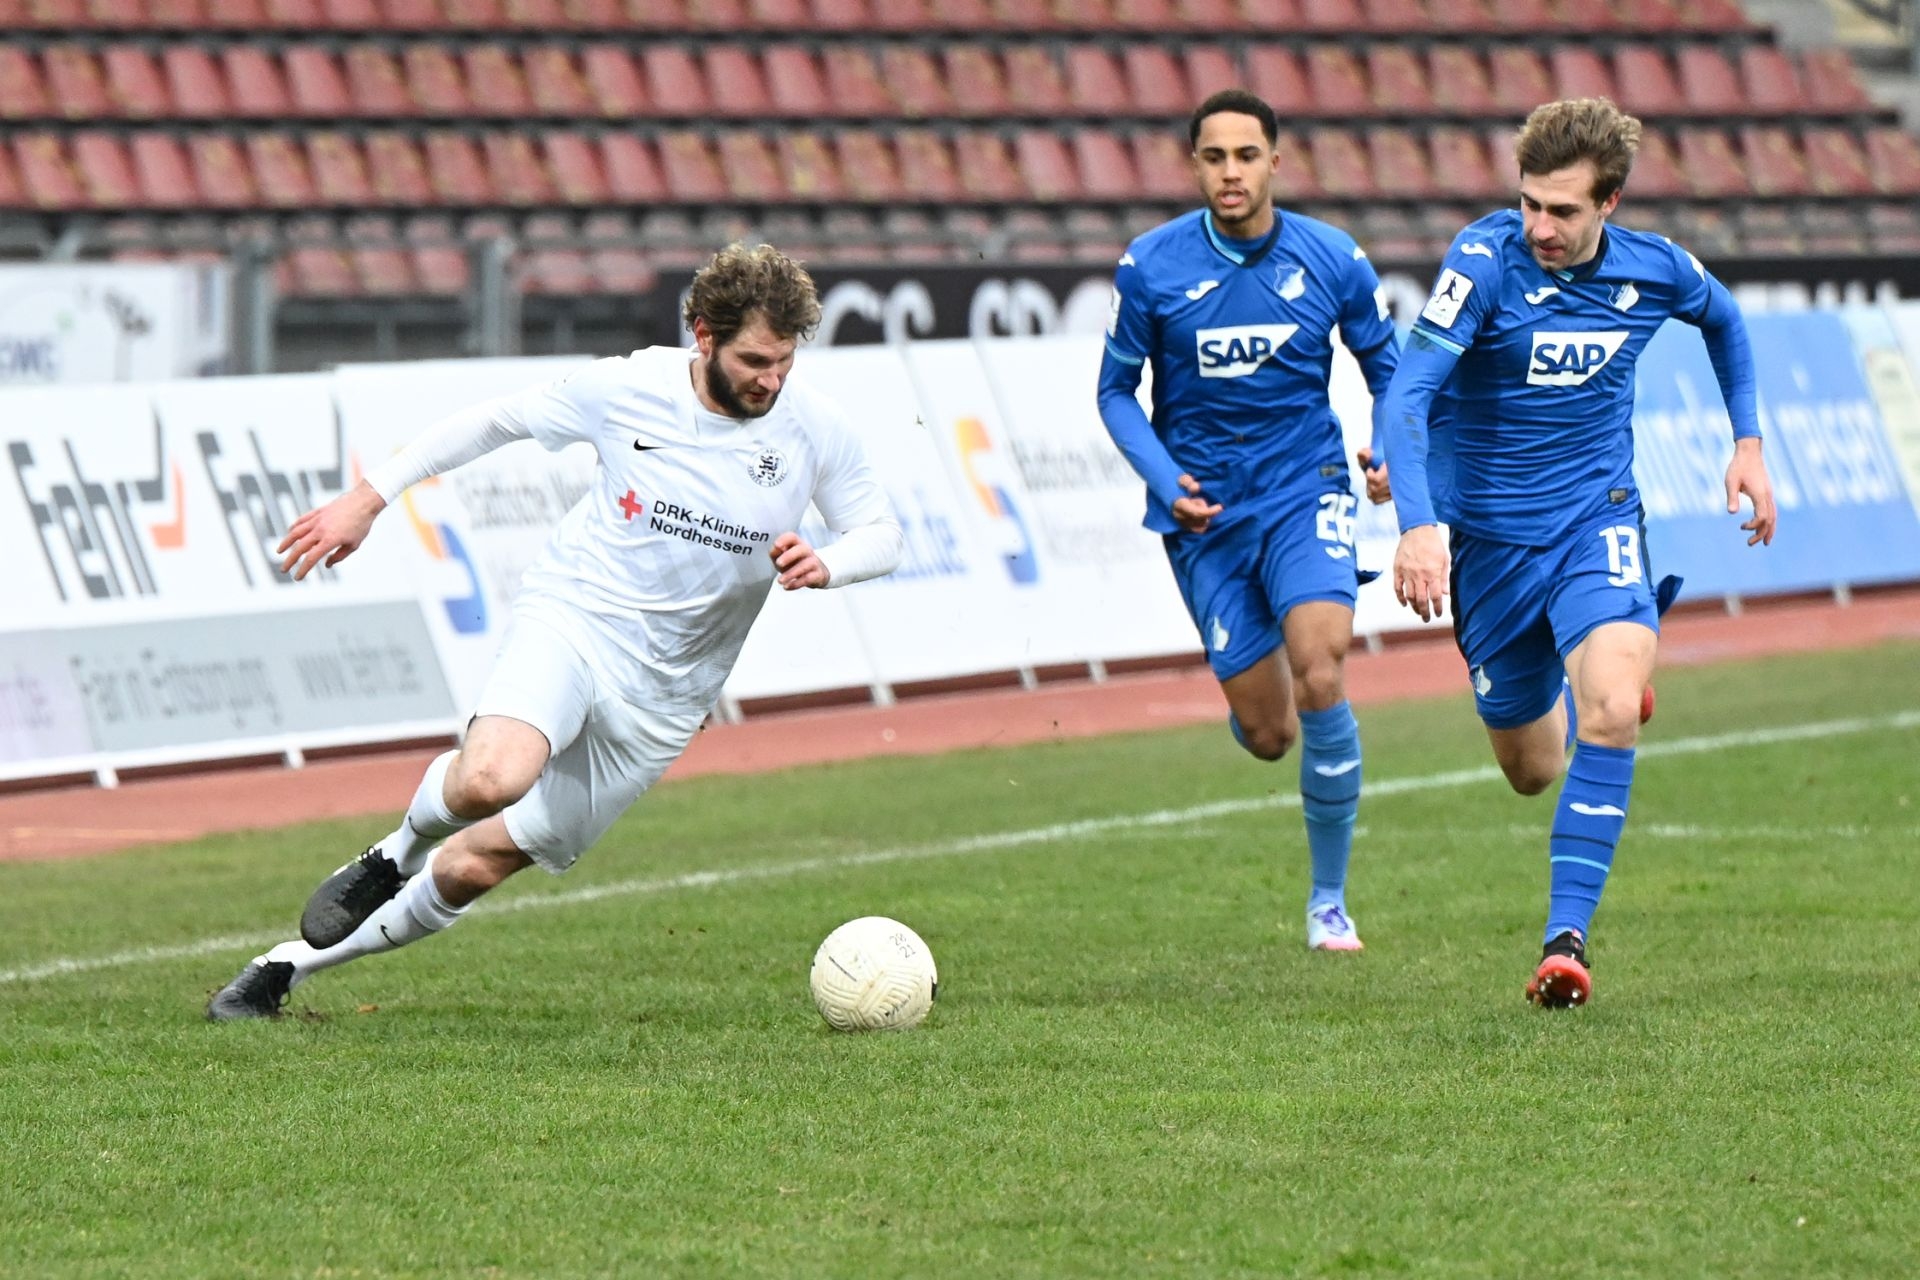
[{"left": 0, "top": 710, "right": 1920, "bottom": 986}]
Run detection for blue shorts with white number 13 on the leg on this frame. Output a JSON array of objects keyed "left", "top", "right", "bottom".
[{"left": 1452, "top": 510, "right": 1678, "bottom": 729}]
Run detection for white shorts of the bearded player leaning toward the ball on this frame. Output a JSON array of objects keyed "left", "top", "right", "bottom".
[{"left": 474, "top": 618, "right": 707, "bottom": 875}]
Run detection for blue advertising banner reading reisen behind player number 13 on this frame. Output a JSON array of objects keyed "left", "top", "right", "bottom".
[{"left": 1634, "top": 311, "right": 1920, "bottom": 599}]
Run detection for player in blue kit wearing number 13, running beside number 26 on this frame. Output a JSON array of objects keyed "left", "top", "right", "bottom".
[{"left": 1379, "top": 98, "right": 1776, "bottom": 1007}]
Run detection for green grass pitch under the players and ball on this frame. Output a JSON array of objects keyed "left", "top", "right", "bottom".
[{"left": 0, "top": 645, "right": 1920, "bottom": 1280}]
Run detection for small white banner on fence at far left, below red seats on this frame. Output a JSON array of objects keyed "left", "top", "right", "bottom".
[{"left": 0, "top": 263, "right": 230, "bottom": 386}]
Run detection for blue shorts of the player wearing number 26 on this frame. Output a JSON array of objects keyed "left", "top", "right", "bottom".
[{"left": 1165, "top": 487, "right": 1359, "bottom": 679}]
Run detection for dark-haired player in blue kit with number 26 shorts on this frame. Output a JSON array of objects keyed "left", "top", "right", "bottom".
[{"left": 1100, "top": 90, "right": 1398, "bottom": 952}]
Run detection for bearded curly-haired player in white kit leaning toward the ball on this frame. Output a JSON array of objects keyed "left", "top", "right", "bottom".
[{"left": 207, "top": 244, "right": 902, "bottom": 1021}]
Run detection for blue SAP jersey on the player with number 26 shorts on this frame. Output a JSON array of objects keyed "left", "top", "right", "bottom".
[{"left": 1100, "top": 209, "right": 1396, "bottom": 533}]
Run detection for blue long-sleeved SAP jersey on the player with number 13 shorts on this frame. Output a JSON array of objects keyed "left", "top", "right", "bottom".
[{"left": 1386, "top": 209, "right": 1759, "bottom": 547}]
